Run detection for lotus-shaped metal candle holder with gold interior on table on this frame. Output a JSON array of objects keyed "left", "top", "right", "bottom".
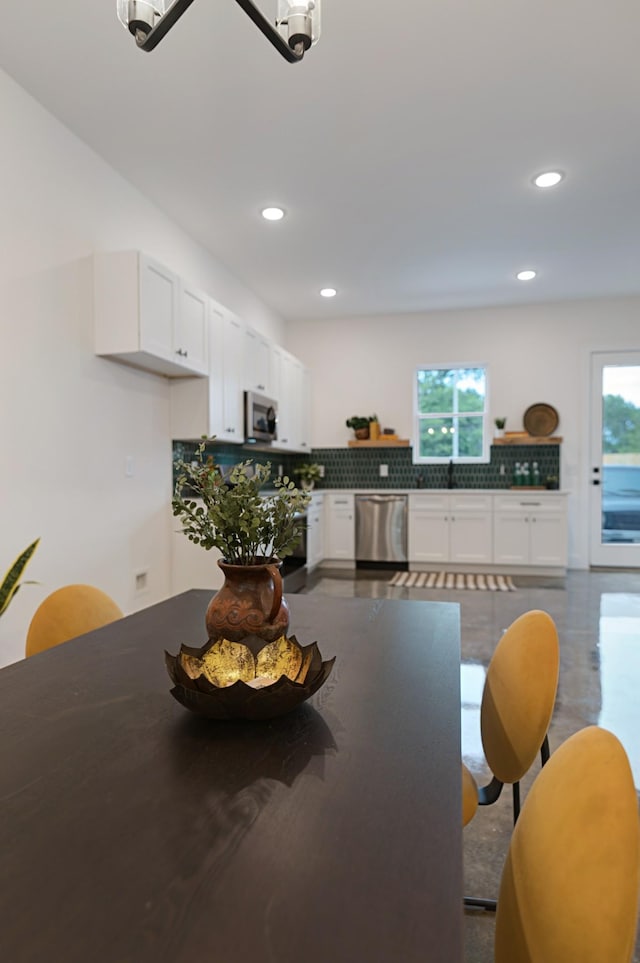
[{"left": 165, "top": 635, "right": 335, "bottom": 719}]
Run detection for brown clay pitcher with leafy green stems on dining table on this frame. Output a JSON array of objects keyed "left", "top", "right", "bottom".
[{"left": 171, "top": 439, "right": 311, "bottom": 641}]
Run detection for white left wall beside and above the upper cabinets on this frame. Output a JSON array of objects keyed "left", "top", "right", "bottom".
[{"left": 0, "top": 72, "right": 284, "bottom": 665}]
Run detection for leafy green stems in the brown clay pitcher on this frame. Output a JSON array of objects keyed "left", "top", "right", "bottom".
[{"left": 171, "top": 439, "right": 311, "bottom": 565}]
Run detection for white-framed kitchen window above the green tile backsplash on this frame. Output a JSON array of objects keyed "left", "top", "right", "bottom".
[{"left": 414, "top": 365, "right": 489, "bottom": 463}]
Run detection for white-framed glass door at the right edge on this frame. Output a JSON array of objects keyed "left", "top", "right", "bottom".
[{"left": 590, "top": 351, "right": 640, "bottom": 567}]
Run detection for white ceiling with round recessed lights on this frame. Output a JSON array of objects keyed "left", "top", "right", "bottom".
[{"left": 0, "top": 0, "right": 640, "bottom": 320}]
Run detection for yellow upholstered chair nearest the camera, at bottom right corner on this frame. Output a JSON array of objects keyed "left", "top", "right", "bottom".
[{"left": 495, "top": 726, "right": 640, "bottom": 963}]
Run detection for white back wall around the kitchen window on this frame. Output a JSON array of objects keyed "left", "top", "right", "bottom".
[{"left": 286, "top": 298, "right": 640, "bottom": 568}]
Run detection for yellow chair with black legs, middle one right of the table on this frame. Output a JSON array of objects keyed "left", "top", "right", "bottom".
[{"left": 462, "top": 609, "right": 560, "bottom": 910}]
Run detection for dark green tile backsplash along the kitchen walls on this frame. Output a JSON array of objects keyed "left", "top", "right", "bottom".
[{"left": 173, "top": 441, "right": 560, "bottom": 489}]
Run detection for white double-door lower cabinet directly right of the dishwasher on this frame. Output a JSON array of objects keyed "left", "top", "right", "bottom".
[{"left": 409, "top": 492, "right": 493, "bottom": 565}]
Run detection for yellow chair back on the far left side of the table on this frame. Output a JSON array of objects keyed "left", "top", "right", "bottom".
[{"left": 26, "top": 585, "right": 123, "bottom": 657}]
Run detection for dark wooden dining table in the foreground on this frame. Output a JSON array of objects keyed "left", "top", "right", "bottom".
[{"left": 0, "top": 590, "right": 463, "bottom": 963}]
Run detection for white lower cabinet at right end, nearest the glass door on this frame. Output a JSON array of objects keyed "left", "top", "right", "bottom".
[{"left": 493, "top": 493, "right": 567, "bottom": 568}]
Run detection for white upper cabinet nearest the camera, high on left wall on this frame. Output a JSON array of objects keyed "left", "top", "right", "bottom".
[{"left": 94, "top": 251, "right": 208, "bottom": 377}]
